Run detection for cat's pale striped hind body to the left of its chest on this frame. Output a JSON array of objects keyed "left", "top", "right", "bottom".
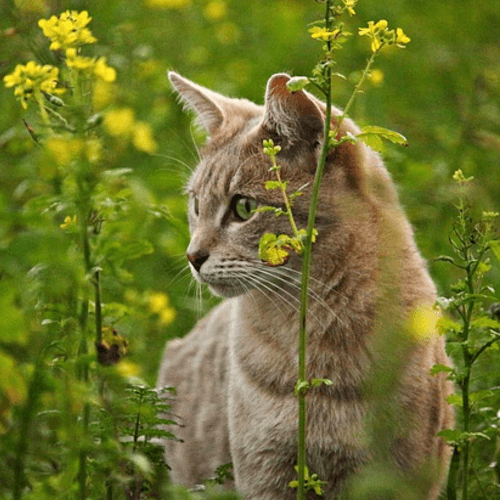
[{"left": 157, "top": 300, "right": 232, "bottom": 486}]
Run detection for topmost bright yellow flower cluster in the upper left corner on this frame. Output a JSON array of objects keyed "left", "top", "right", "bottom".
[{"left": 38, "top": 10, "right": 97, "bottom": 50}]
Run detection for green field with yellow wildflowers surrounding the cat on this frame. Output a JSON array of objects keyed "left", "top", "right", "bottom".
[{"left": 0, "top": 0, "right": 500, "bottom": 500}]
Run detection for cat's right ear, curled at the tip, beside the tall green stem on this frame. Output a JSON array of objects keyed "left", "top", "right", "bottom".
[{"left": 262, "top": 73, "right": 324, "bottom": 145}]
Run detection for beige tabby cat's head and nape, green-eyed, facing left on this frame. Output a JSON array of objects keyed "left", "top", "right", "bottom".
[{"left": 169, "top": 73, "right": 394, "bottom": 297}]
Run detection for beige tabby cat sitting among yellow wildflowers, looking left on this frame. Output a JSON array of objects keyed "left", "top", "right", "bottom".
[{"left": 158, "top": 72, "right": 453, "bottom": 500}]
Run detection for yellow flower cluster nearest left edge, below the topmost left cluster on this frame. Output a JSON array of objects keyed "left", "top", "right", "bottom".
[{"left": 3, "top": 61, "right": 64, "bottom": 109}]
